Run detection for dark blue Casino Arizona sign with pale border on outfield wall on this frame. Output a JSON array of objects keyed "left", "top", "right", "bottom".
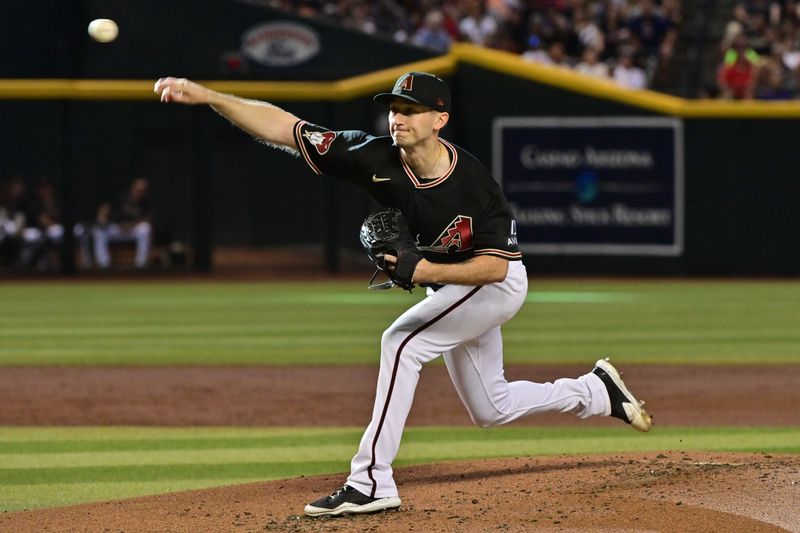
[{"left": 493, "top": 117, "right": 683, "bottom": 256}]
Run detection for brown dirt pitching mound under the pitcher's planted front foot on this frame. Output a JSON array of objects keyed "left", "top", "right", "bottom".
[{"left": 0, "top": 452, "right": 800, "bottom": 533}]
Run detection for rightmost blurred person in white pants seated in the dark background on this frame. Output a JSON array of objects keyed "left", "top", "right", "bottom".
[{"left": 92, "top": 178, "right": 153, "bottom": 268}]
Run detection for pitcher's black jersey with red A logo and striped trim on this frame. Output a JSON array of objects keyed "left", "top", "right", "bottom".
[{"left": 294, "top": 121, "right": 522, "bottom": 263}]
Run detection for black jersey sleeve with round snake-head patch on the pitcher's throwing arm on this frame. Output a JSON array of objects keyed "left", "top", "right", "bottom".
[{"left": 294, "top": 120, "right": 372, "bottom": 182}]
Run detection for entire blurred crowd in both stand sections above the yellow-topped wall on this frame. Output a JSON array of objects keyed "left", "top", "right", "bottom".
[{"left": 262, "top": 0, "right": 800, "bottom": 99}]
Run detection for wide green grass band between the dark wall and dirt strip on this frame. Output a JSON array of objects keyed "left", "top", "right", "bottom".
[{"left": 0, "top": 280, "right": 800, "bottom": 365}]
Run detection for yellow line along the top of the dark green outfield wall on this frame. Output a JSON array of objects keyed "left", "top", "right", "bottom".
[{"left": 0, "top": 44, "right": 800, "bottom": 118}]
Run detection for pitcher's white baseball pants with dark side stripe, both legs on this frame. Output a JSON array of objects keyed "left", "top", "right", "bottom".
[{"left": 347, "top": 261, "right": 611, "bottom": 498}]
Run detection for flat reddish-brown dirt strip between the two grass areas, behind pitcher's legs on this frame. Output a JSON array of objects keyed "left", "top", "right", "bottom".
[{"left": 0, "top": 365, "right": 800, "bottom": 426}]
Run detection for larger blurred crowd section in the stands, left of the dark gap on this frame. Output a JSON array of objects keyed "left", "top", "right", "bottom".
[{"left": 265, "top": 0, "right": 681, "bottom": 88}]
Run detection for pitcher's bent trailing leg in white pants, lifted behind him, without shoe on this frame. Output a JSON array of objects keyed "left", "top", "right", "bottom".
[{"left": 444, "top": 327, "right": 610, "bottom": 427}]
